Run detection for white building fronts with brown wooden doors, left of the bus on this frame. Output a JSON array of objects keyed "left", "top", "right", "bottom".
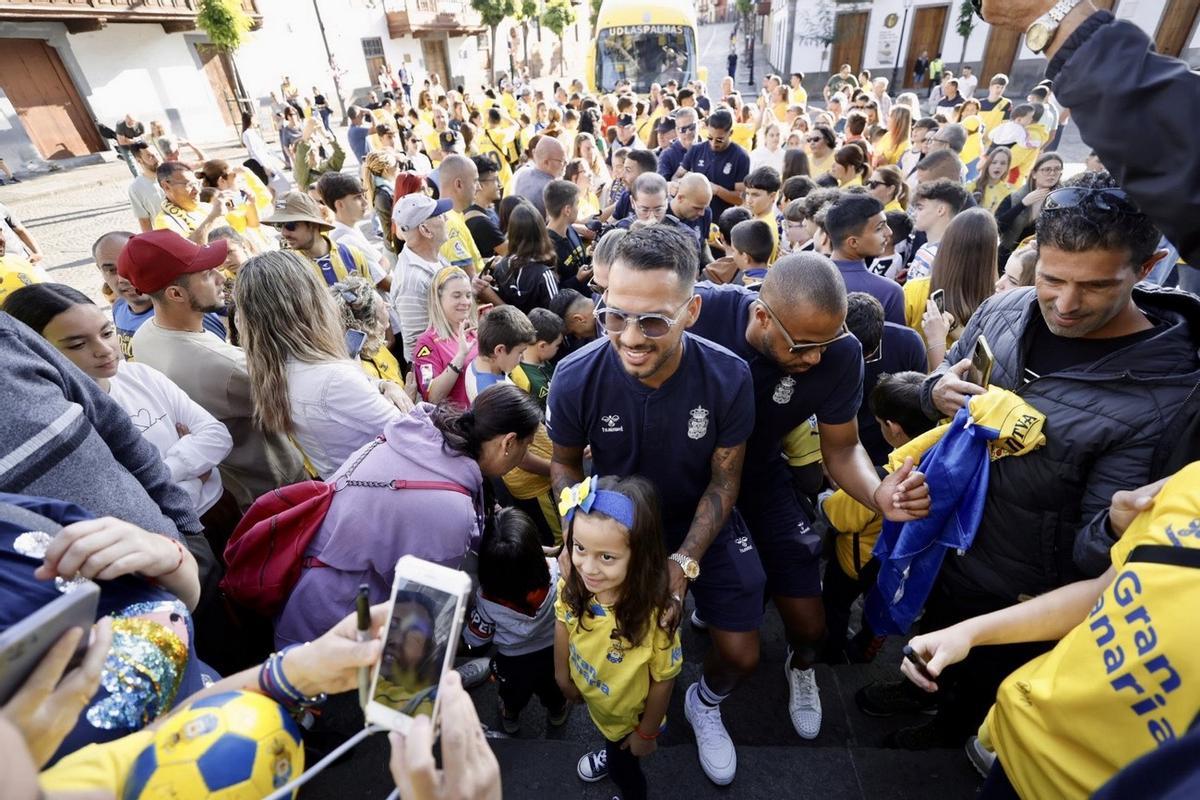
[{"left": 0, "top": 0, "right": 590, "bottom": 170}]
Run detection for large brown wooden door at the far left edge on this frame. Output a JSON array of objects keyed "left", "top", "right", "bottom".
[{"left": 0, "top": 38, "right": 101, "bottom": 158}]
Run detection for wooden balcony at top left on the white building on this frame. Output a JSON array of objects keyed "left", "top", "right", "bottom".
[{"left": 0, "top": 0, "right": 263, "bottom": 34}]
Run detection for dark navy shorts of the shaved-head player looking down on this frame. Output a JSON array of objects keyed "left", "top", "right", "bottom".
[{"left": 737, "top": 459, "right": 821, "bottom": 597}]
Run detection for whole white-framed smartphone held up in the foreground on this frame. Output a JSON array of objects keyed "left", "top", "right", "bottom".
[{"left": 366, "top": 555, "right": 470, "bottom": 733}]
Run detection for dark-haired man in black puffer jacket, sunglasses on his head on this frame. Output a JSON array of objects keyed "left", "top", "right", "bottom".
[{"left": 858, "top": 173, "right": 1200, "bottom": 748}]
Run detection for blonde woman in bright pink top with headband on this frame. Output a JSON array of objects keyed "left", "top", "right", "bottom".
[{"left": 413, "top": 266, "right": 479, "bottom": 408}]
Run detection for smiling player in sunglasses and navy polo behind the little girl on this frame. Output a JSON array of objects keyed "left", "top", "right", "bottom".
[{"left": 546, "top": 224, "right": 766, "bottom": 784}]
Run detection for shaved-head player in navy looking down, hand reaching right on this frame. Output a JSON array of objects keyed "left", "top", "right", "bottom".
[{"left": 691, "top": 253, "right": 929, "bottom": 739}]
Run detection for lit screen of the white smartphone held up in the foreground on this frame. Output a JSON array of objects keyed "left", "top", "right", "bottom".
[{"left": 372, "top": 581, "right": 457, "bottom": 716}]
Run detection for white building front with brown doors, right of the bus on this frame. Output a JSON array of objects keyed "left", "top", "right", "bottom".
[{"left": 768, "top": 0, "right": 1200, "bottom": 91}]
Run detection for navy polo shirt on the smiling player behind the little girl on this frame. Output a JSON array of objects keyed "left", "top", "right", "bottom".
[{"left": 546, "top": 333, "right": 754, "bottom": 547}]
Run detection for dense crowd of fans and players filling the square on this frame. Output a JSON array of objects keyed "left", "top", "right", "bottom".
[{"left": 0, "top": 2, "right": 1200, "bottom": 800}]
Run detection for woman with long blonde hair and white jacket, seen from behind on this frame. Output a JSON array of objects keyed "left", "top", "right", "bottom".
[{"left": 234, "top": 251, "right": 413, "bottom": 480}]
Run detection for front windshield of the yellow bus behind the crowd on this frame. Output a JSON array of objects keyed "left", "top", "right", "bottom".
[{"left": 596, "top": 25, "right": 696, "bottom": 94}]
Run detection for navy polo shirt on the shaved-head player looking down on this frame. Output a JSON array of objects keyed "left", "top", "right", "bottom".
[{"left": 688, "top": 282, "right": 863, "bottom": 486}]
